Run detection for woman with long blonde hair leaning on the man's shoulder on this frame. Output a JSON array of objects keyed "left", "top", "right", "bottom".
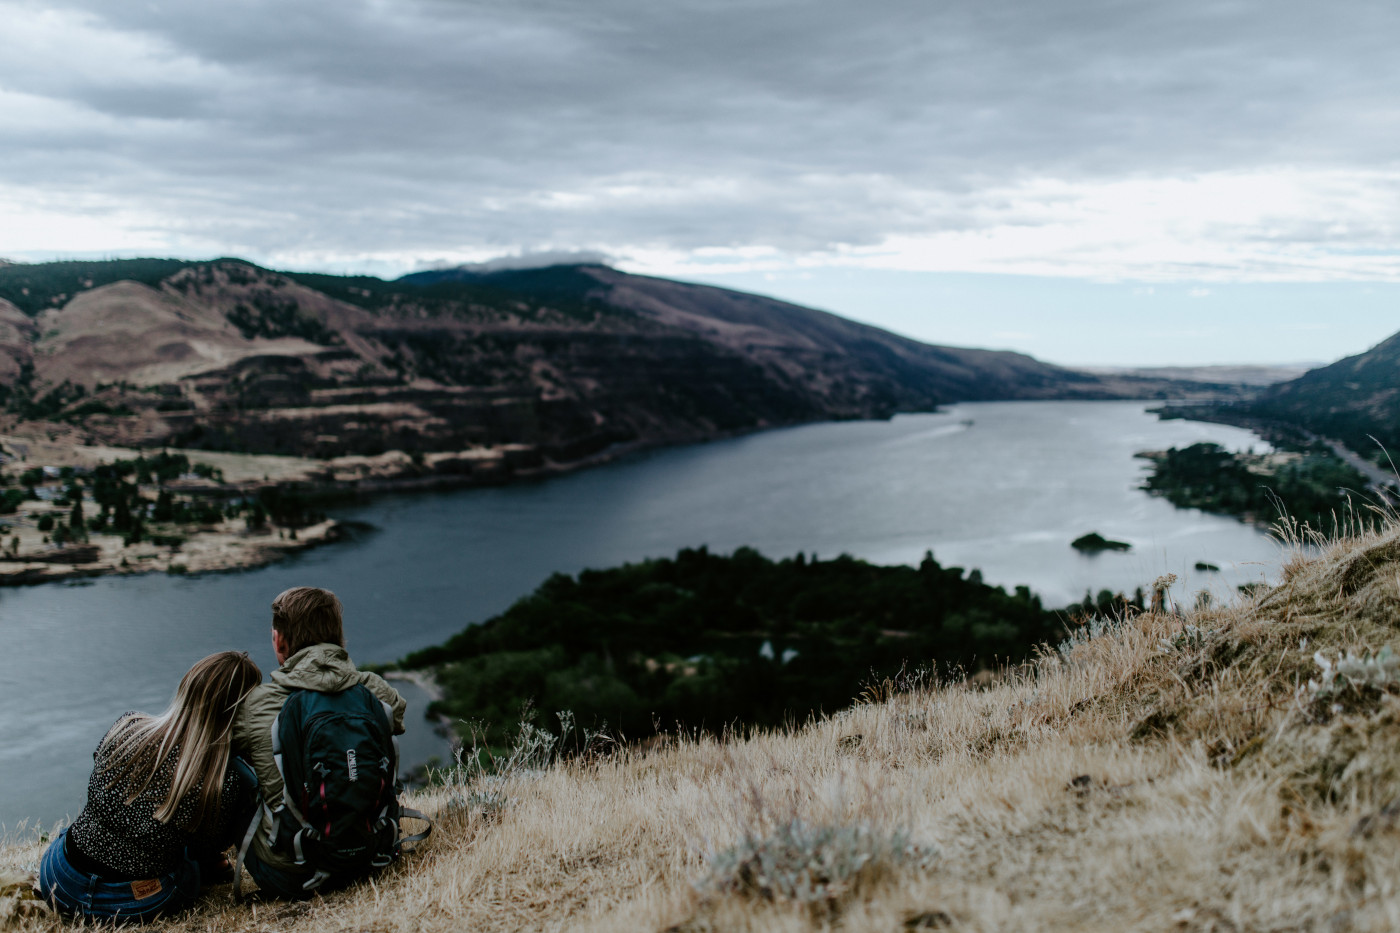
[{"left": 39, "top": 651, "right": 262, "bottom": 922}]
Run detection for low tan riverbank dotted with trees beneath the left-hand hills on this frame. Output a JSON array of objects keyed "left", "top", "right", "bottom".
[{"left": 0, "top": 425, "right": 655, "bottom": 587}]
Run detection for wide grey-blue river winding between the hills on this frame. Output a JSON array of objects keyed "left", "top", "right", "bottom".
[{"left": 0, "top": 402, "right": 1280, "bottom": 831}]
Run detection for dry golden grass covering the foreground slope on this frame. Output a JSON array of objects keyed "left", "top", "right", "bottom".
[{"left": 8, "top": 527, "right": 1400, "bottom": 933}]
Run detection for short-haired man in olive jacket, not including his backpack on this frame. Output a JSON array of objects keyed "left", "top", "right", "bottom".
[{"left": 232, "top": 587, "right": 407, "bottom": 898}]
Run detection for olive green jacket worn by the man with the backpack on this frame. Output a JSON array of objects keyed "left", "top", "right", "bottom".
[{"left": 234, "top": 644, "right": 409, "bottom": 874}]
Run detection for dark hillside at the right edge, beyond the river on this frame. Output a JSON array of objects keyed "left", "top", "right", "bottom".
[{"left": 1246, "top": 326, "right": 1400, "bottom": 457}]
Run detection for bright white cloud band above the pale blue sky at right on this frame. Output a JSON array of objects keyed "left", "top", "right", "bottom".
[{"left": 633, "top": 170, "right": 1400, "bottom": 281}]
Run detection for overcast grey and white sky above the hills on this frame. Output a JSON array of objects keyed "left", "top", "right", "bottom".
[{"left": 0, "top": 0, "right": 1400, "bottom": 364}]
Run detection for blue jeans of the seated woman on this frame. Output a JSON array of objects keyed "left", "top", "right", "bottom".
[{"left": 39, "top": 829, "right": 200, "bottom": 923}]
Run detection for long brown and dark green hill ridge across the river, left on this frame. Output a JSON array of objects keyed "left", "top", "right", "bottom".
[{"left": 0, "top": 259, "right": 1239, "bottom": 472}]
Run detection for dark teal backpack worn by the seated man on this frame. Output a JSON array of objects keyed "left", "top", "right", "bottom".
[{"left": 234, "top": 684, "right": 433, "bottom": 897}]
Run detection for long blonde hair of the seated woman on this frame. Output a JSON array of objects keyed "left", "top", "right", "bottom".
[{"left": 101, "top": 651, "right": 262, "bottom": 829}]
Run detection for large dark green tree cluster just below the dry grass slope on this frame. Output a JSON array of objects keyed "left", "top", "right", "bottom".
[{"left": 403, "top": 548, "right": 1064, "bottom": 742}]
